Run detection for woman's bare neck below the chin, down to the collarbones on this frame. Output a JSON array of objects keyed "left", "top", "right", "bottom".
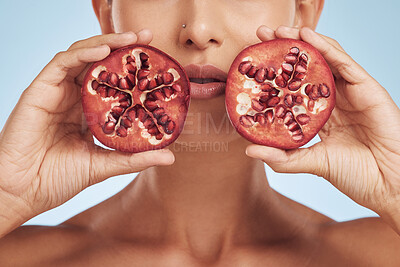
[{"left": 111, "top": 138, "right": 304, "bottom": 258}]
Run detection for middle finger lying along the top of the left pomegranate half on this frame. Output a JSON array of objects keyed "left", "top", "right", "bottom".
[{"left": 68, "top": 32, "right": 138, "bottom": 51}]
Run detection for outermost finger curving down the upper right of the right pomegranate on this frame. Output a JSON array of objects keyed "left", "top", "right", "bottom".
[{"left": 300, "top": 28, "right": 369, "bottom": 84}]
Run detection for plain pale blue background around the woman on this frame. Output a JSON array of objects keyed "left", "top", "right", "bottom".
[{"left": 0, "top": 0, "right": 400, "bottom": 225}]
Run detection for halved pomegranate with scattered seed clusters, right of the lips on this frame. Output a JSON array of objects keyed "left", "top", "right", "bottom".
[{"left": 225, "top": 39, "right": 336, "bottom": 149}]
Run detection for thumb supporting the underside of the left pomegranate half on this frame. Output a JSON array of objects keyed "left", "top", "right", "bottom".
[{"left": 90, "top": 148, "right": 175, "bottom": 184}]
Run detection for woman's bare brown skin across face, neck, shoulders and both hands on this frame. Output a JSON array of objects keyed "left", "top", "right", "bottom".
[{"left": 0, "top": 0, "right": 400, "bottom": 266}]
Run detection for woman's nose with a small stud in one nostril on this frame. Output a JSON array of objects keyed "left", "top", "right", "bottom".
[{"left": 179, "top": 0, "right": 224, "bottom": 50}]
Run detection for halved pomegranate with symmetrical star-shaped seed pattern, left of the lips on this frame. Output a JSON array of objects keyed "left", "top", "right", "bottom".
[{"left": 82, "top": 45, "right": 190, "bottom": 152}]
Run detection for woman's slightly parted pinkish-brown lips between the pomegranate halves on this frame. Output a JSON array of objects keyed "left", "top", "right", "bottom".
[{"left": 184, "top": 64, "right": 228, "bottom": 99}]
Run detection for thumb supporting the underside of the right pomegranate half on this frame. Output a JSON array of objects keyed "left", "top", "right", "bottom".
[{"left": 246, "top": 143, "right": 329, "bottom": 178}]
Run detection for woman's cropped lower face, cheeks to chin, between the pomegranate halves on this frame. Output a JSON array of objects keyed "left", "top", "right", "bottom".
[{"left": 111, "top": 0, "right": 296, "bottom": 149}]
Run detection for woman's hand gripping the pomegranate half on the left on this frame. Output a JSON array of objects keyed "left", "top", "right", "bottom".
[{"left": 0, "top": 30, "right": 174, "bottom": 232}]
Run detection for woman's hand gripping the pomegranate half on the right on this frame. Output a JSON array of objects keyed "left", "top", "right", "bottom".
[{"left": 246, "top": 26, "right": 400, "bottom": 228}]
